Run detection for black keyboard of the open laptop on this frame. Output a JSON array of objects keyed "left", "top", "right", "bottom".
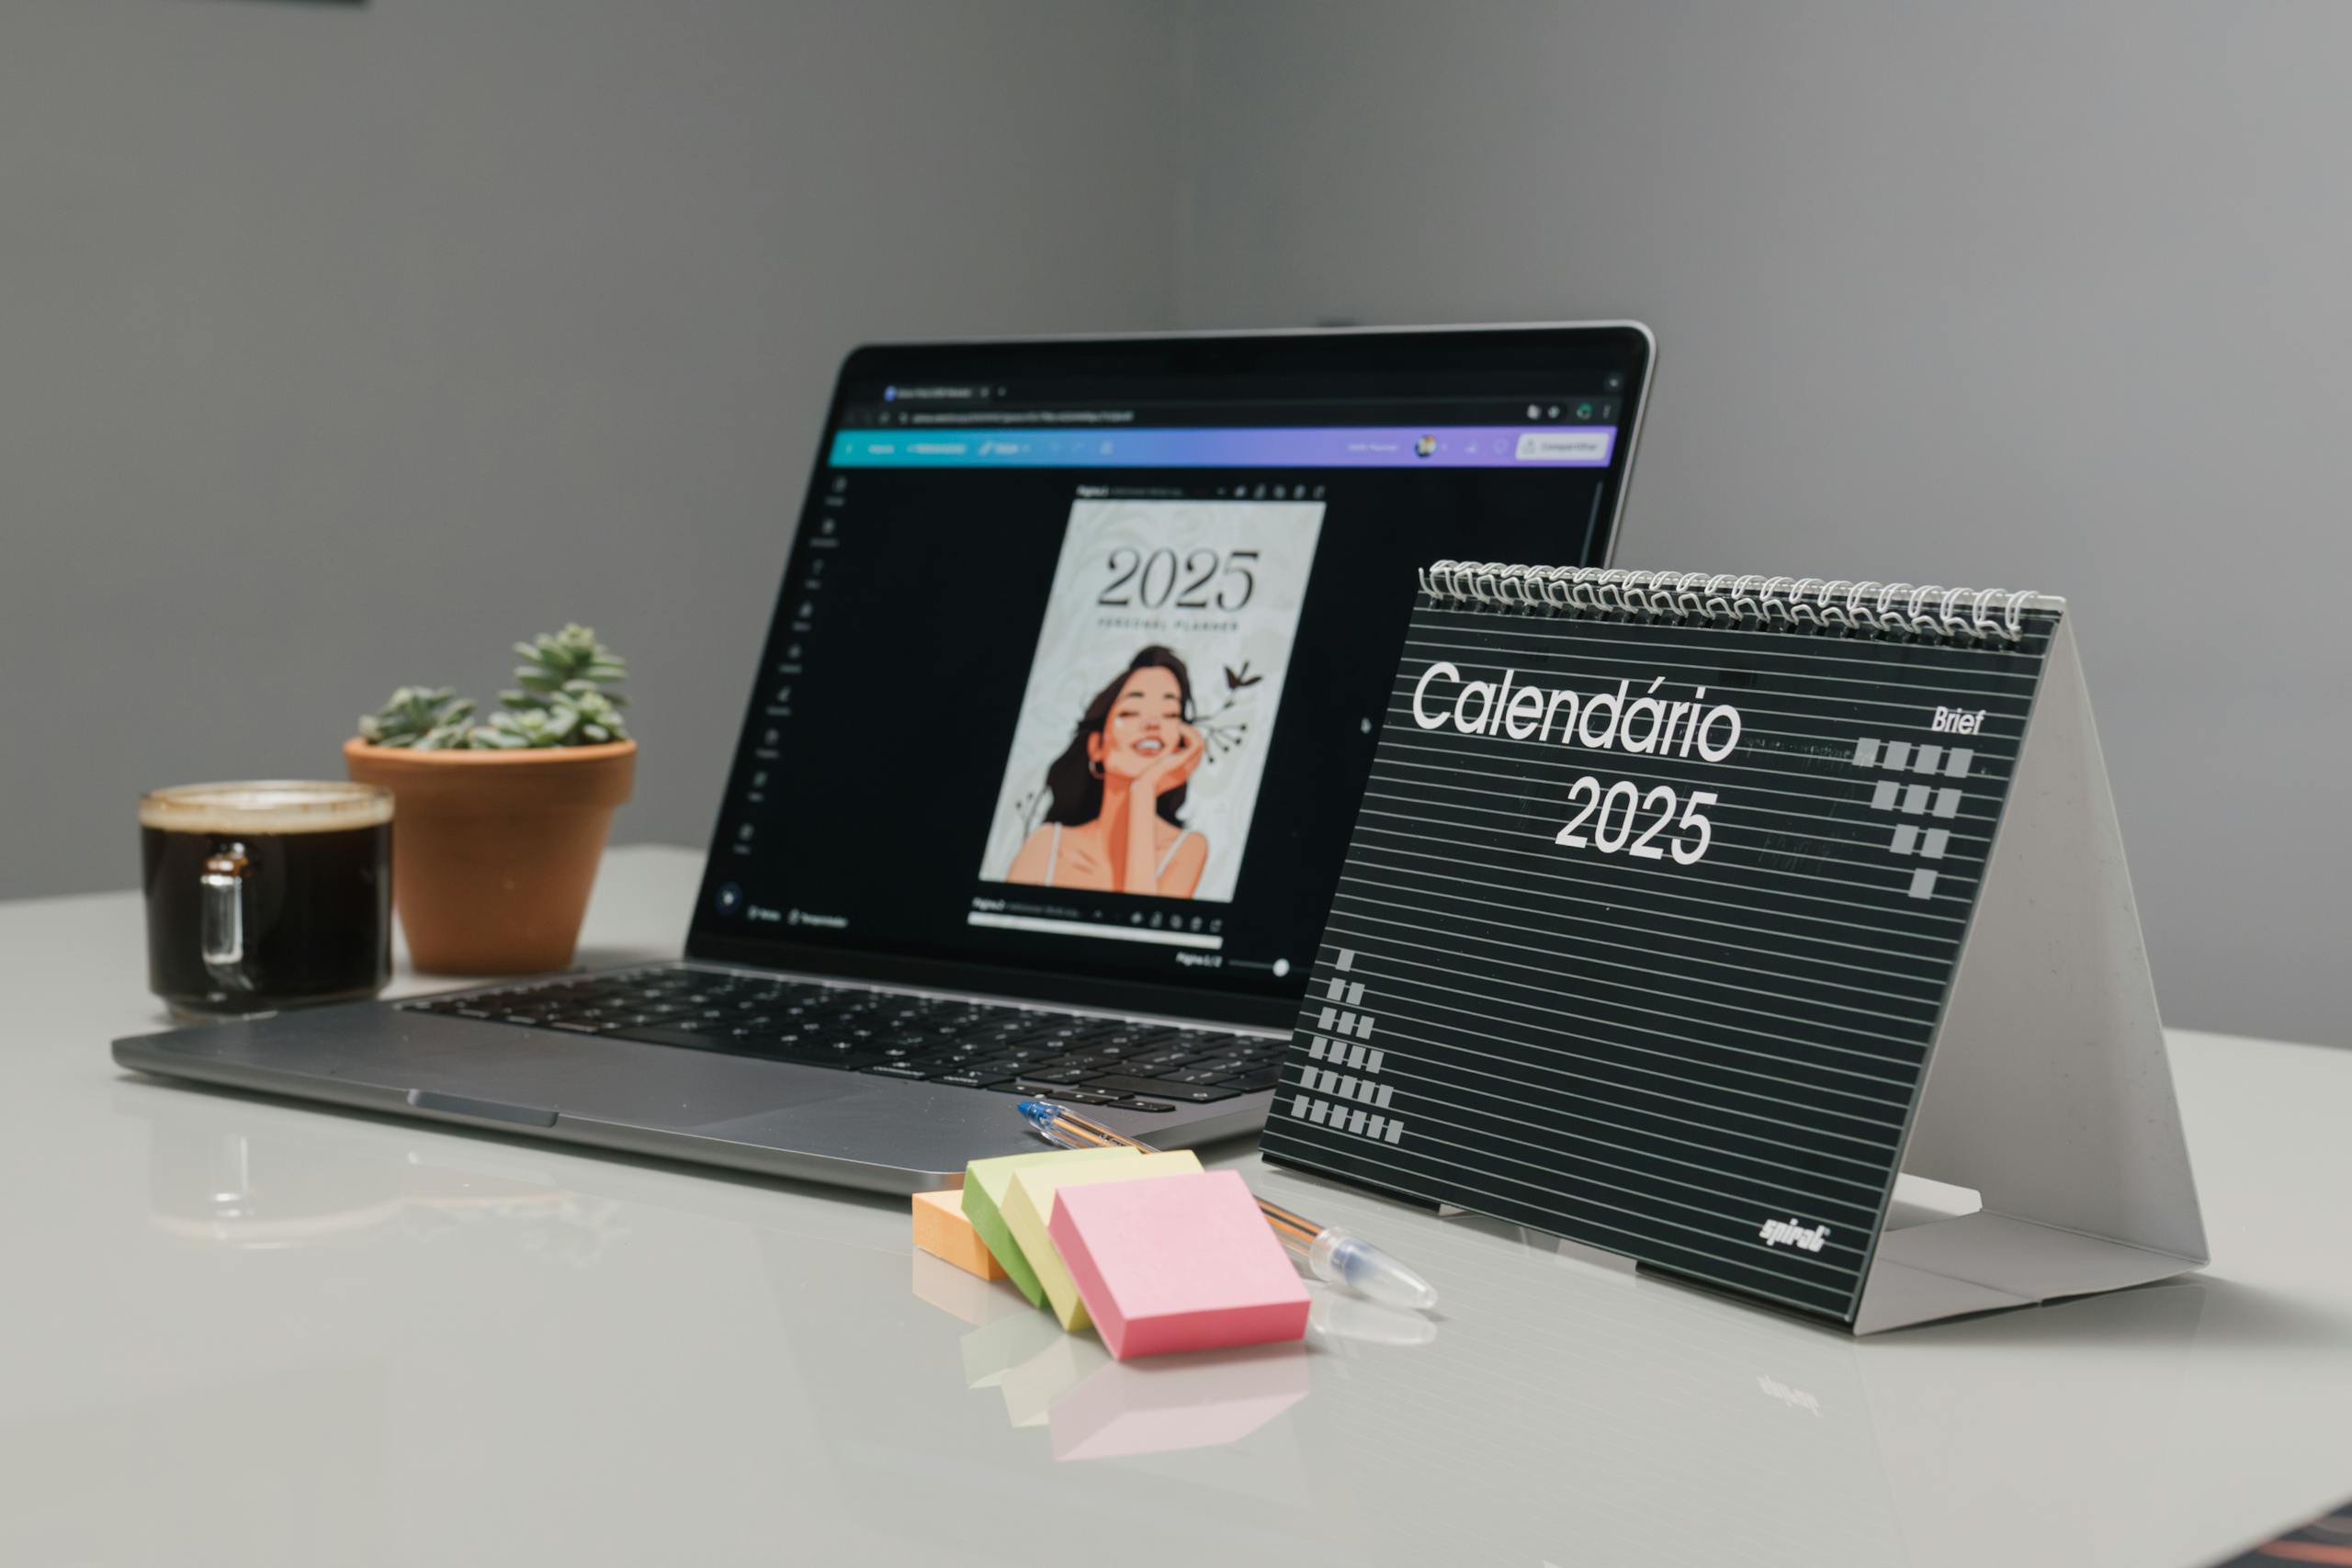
[{"left": 400, "top": 968, "right": 1289, "bottom": 1112}]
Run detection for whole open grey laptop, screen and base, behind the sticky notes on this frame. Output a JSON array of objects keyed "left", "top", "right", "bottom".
[{"left": 115, "top": 322, "right": 1654, "bottom": 1192}]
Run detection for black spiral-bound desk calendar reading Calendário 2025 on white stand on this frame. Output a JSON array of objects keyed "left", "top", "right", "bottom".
[{"left": 1263, "top": 562, "right": 2206, "bottom": 1333}]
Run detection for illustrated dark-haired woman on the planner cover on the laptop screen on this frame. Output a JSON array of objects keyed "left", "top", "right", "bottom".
[{"left": 1004, "top": 644, "right": 1209, "bottom": 898}]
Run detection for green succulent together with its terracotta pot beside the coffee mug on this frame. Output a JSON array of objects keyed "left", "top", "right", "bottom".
[{"left": 344, "top": 626, "right": 638, "bottom": 976}]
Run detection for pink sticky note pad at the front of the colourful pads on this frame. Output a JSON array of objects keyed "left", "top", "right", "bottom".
[{"left": 1046, "top": 1170, "right": 1307, "bottom": 1361}]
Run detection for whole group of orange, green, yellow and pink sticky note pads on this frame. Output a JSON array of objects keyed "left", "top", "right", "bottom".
[{"left": 915, "top": 1147, "right": 1307, "bottom": 1361}]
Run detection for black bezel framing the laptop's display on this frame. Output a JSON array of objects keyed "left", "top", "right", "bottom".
[{"left": 687, "top": 322, "right": 1658, "bottom": 1027}]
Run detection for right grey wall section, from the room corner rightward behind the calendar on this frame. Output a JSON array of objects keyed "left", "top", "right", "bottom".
[{"left": 1181, "top": 0, "right": 2352, "bottom": 1043}]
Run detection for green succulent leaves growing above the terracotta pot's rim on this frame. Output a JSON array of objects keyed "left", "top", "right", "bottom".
[{"left": 360, "top": 626, "right": 628, "bottom": 752}]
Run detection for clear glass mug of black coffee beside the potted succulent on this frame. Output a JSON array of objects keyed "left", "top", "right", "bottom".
[{"left": 139, "top": 781, "right": 393, "bottom": 1021}]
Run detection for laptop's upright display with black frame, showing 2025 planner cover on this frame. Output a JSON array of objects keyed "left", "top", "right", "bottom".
[{"left": 689, "top": 327, "right": 1649, "bottom": 1025}]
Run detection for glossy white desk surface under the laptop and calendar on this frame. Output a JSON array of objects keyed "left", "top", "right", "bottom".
[{"left": 0, "top": 849, "right": 2352, "bottom": 1568}]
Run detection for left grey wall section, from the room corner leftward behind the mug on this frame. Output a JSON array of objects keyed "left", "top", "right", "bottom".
[{"left": 0, "top": 0, "right": 1179, "bottom": 896}]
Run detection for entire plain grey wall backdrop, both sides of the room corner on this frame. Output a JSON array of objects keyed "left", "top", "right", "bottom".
[{"left": 0, "top": 0, "right": 2352, "bottom": 1042}]
